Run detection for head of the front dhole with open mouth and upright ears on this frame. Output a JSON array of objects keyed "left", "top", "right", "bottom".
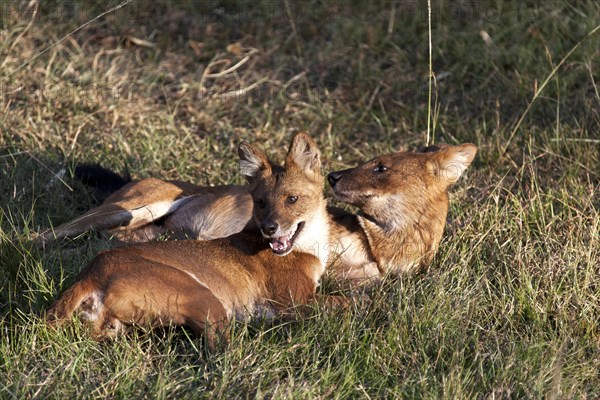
[{"left": 238, "top": 133, "right": 325, "bottom": 255}]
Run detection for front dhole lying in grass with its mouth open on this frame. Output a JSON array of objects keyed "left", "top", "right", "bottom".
[{"left": 47, "top": 133, "right": 345, "bottom": 346}]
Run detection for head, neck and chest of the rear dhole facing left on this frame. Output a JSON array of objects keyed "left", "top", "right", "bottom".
[{"left": 328, "top": 144, "right": 477, "bottom": 282}]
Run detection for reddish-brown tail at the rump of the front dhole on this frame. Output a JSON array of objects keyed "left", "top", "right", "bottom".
[{"left": 46, "top": 281, "right": 97, "bottom": 325}]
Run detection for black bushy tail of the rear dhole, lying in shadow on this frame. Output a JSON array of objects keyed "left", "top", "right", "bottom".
[{"left": 75, "top": 164, "right": 131, "bottom": 204}]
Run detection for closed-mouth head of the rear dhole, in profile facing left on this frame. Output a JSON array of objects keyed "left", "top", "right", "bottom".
[{"left": 327, "top": 144, "right": 477, "bottom": 222}]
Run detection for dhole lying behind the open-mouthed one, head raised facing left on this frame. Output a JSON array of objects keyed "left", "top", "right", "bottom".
[{"left": 43, "top": 144, "right": 477, "bottom": 283}]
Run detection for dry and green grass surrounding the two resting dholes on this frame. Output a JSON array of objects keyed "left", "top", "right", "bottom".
[{"left": 0, "top": 0, "right": 600, "bottom": 399}]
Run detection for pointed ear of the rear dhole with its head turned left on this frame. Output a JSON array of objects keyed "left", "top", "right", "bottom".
[{"left": 431, "top": 143, "right": 477, "bottom": 185}]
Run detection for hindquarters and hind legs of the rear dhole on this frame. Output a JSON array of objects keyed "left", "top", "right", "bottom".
[{"left": 36, "top": 168, "right": 255, "bottom": 243}]
